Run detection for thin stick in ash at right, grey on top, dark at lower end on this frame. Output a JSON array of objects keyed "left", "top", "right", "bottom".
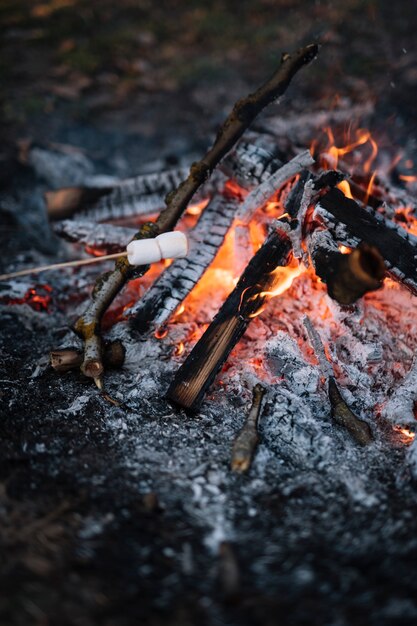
[{"left": 303, "top": 315, "right": 374, "bottom": 446}]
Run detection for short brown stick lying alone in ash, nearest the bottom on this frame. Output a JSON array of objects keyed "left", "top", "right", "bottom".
[{"left": 232, "top": 383, "right": 266, "bottom": 474}]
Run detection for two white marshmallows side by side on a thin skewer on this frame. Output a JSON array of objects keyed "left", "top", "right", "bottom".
[{"left": 126, "top": 230, "right": 188, "bottom": 265}]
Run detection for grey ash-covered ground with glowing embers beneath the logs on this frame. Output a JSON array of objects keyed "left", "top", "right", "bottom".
[{"left": 0, "top": 106, "right": 417, "bottom": 626}]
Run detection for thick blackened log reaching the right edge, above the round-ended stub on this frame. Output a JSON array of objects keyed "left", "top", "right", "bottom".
[{"left": 314, "top": 189, "right": 417, "bottom": 295}]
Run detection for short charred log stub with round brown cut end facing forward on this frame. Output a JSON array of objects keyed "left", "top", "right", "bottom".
[{"left": 308, "top": 230, "right": 385, "bottom": 305}]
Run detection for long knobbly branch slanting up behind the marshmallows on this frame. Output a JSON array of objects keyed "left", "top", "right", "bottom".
[{"left": 74, "top": 44, "right": 318, "bottom": 388}]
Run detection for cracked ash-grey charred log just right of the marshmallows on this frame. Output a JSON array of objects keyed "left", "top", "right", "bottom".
[{"left": 128, "top": 196, "right": 239, "bottom": 332}]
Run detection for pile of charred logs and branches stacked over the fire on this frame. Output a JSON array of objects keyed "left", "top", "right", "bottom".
[{"left": 48, "top": 45, "right": 417, "bottom": 454}]
